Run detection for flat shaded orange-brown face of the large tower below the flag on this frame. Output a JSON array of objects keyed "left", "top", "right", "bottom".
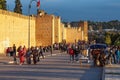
[{"left": 36, "top": 15, "right": 54, "bottom": 46}]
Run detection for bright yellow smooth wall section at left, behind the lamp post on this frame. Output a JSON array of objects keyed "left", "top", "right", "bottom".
[{"left": 0, "top": 10, "right": 36, "bottom": 53}]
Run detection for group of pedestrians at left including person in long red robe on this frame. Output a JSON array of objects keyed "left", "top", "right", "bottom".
[{"left": 6, "top": 44, "right": 44, "bottom": 65}]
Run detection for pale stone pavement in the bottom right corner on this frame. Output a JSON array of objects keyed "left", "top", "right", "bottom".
[{"left": 104, "top": 64, "right": 120, "bottom": 80}]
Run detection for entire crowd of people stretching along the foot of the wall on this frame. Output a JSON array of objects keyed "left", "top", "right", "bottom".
[{"left": 6, "top": 42, "right": 120, "bottom": 65}]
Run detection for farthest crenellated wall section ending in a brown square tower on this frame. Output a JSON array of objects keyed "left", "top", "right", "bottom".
[{"left": 64, "top": 21, "right": 88, "bottom": 43}]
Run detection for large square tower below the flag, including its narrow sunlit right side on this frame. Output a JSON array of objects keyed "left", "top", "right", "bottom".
[{"left": 36, "top": 14, "right": 62, "bottom": 46}]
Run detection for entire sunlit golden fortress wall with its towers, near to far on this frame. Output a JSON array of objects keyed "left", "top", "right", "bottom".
[{"left": 0, "top": 10, "right": 88, "bottom": 53}]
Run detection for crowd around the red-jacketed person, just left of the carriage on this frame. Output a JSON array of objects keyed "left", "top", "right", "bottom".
[{"left": 61, "top": 41, "right": 90, "bottom": 63}]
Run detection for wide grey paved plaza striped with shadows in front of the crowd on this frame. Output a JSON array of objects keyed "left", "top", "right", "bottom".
[{"left": 0, "top": 53, "right": 102, "bottom": 80}]
